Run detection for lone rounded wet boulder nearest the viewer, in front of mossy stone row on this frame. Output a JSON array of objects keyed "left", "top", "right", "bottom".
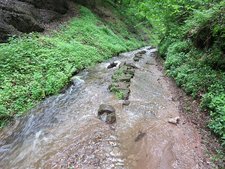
[{"left": 98, "top": 104, "right": 116, "bottom": 124}]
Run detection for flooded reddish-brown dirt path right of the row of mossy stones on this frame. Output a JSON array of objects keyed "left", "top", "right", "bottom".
[{"left": 119, "top": 48, "right": 208, "bottom": 169}]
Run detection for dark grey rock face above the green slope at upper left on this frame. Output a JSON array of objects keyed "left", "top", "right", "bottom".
[{"left": 0, "top": 0, "right": 68, "bottom": 42}]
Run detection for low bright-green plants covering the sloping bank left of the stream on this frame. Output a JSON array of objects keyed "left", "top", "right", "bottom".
[{"left": 0, "top": 7, "right": 146, "bottom": 127}]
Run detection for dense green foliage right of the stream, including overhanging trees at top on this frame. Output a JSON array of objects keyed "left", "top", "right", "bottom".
[{"left": 118, "top": 0, "right": 225, "bottom": 145}]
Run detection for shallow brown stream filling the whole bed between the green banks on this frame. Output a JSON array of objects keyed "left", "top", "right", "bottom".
[{"left": 0, "top": 47, "right": 210, "bottom": 169}]
